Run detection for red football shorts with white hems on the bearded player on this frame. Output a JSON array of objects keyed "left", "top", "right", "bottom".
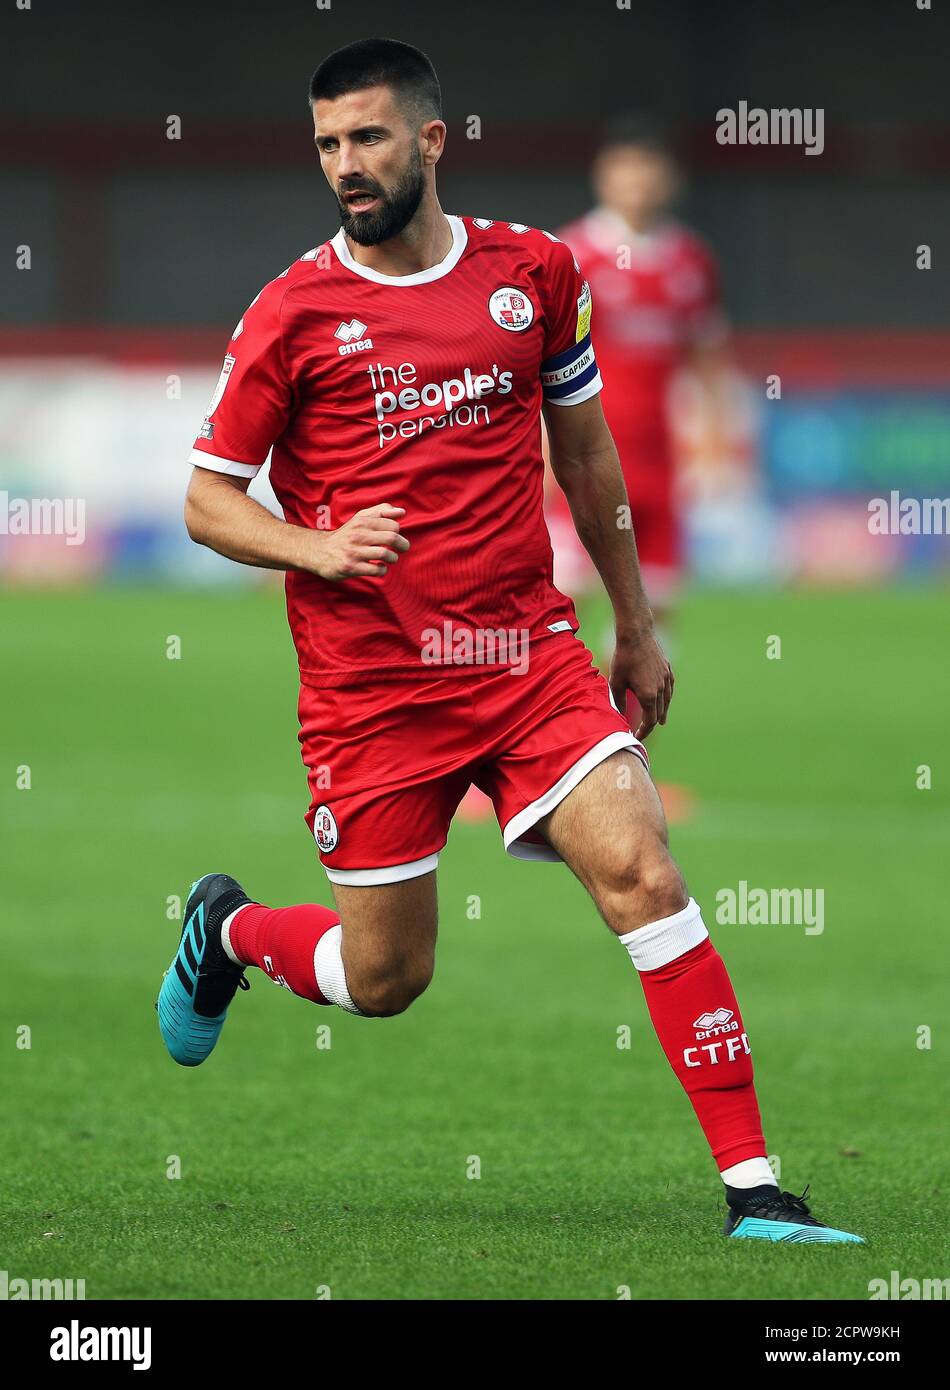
[{"left": 299, "top": 632, "right": 650, "bottom": 885}]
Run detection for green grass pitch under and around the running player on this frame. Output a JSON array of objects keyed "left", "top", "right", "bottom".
[{"left": 0, "top": 588, "right": 950, "bottom": 1300}]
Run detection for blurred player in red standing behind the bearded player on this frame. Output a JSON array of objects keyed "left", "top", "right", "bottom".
[{"left": 548, "top": 117, "right": 730, "bottom": 813}]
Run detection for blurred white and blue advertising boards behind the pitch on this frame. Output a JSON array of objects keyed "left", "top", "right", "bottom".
[{"left": 0, "top": 331, "right": 950, "bottom": 589}]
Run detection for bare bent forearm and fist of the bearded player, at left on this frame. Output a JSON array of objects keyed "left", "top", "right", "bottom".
[{"left": 185, "top": 466, "right": 409, "bottom": 581}]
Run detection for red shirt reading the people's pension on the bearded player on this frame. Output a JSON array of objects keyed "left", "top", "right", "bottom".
[{"left": 191, "top": 217, "right": 601, "bottom": 685}]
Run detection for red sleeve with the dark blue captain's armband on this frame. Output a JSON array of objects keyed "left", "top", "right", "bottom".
[{"left": 541, "top": 232, "right": 604, "bottom": 406}]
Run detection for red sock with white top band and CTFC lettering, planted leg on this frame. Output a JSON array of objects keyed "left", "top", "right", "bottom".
[{"left": 620, "top": 899, "right": 766, "bottom": 1169}]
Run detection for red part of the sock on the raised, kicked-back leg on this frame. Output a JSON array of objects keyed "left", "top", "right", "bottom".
[{"left": 230, "top": 902, "right": 339, "bottom": 1004}]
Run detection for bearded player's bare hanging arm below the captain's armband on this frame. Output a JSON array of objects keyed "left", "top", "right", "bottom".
[{"left": 544, "top": 395, "right": 673, "bottom": 738}]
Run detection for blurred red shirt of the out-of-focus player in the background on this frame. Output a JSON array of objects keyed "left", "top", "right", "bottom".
[{"left": 558, "top": 209, "right": 725, "bottom": 499}]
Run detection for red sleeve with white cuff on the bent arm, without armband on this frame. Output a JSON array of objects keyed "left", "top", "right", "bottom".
[{"left": 189, "top": 281, "right": 291, "bottom": 478}]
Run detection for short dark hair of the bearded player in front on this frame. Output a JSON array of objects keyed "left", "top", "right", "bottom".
[{"left": 310, "top": 39, "right": 442, "bottom": 121}]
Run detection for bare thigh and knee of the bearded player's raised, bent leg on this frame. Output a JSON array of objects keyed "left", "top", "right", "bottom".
[{"left": 331, "top": 870, "right": 438, "bottom": 1015}]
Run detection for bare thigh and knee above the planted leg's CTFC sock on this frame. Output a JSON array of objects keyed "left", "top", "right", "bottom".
[{"left": 537, "top": 751, "right": 687, "bottom": 935}]
